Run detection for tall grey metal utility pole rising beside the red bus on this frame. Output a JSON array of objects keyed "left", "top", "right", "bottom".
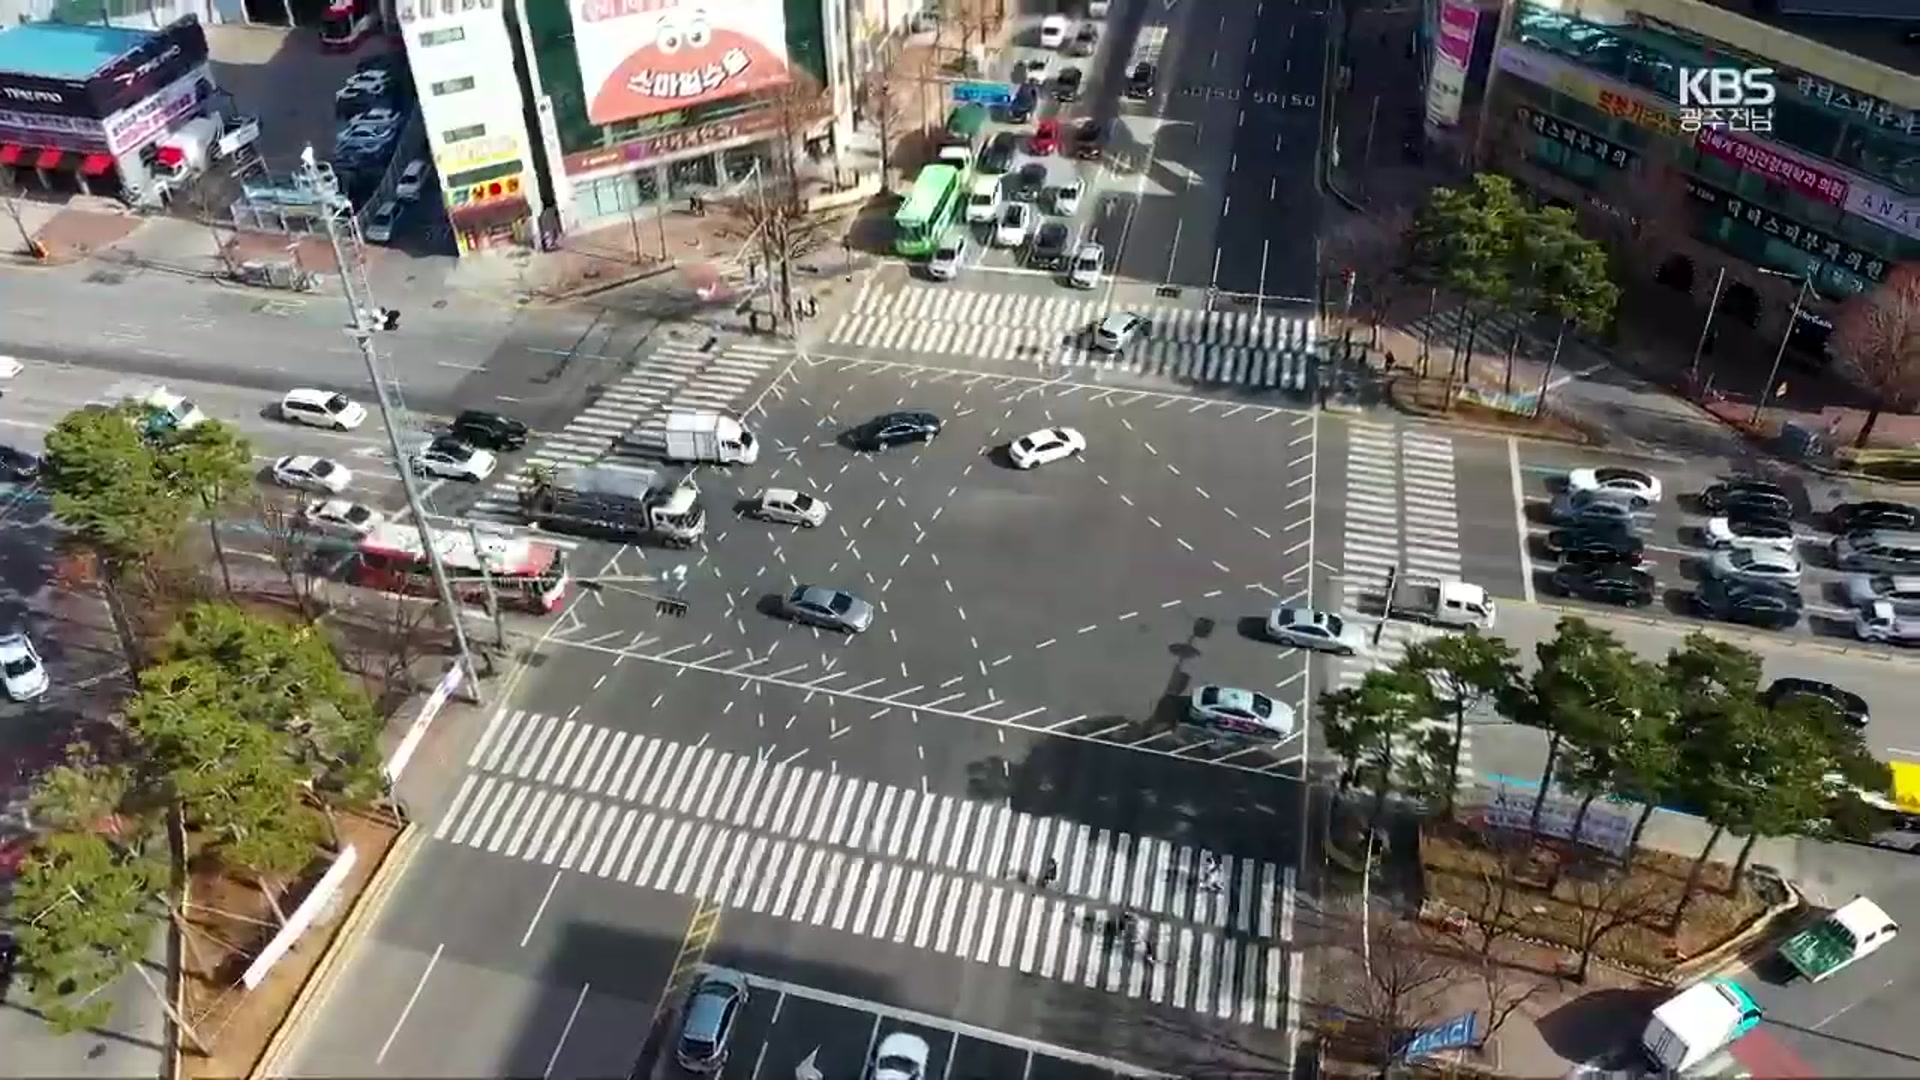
[{"left": 300, "top": 146, "right": 492, "bottom": 705}]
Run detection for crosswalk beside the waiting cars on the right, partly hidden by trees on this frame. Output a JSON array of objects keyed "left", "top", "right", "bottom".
[{"left": 1340, "top": 421, "right": 1473, "bottom": 776}]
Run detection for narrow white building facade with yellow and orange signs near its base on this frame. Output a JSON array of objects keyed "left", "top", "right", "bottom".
[{"left": 397, "top": 0, "right": 543, "bottom": 254}]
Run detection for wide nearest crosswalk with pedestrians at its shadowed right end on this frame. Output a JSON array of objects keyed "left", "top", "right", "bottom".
[{"left": 434, "top": 709, "right": 1298, "bottom": 1028}]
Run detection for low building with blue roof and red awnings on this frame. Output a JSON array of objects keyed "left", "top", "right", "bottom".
[{"left": 0, "top": 15, "right": 219, "bottom": 202}]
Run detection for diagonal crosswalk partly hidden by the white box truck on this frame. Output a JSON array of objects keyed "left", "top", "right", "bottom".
[{"left": 468, "top": 340, "right": 789, "bottom": 525}]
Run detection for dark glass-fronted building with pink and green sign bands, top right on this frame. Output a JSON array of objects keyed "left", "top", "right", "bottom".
[{"left": 1478, "top": 0, "right": 1920, "bottom": 354}]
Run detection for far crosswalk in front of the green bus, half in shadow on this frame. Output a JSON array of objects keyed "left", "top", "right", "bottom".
[{"left": 826, "top": 286, "right": 1319, "bottom": 394}]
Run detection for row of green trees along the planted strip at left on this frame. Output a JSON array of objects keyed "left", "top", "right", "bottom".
[{"left": 8, "top": 404, "right": 384, "bottom": 1040}]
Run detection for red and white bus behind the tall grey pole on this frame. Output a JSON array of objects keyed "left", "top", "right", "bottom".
[{"left": 353, "top": 523, "right": 572, "bottom": 615}]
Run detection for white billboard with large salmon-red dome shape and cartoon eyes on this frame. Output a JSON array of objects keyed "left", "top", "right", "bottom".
[{"left": 574, "top": 0, "right": 787, "bottom": 123}]
